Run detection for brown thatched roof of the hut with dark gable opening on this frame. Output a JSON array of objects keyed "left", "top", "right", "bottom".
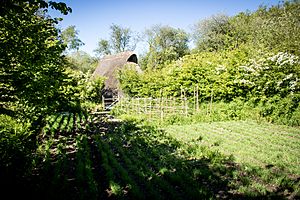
[{"left": 93, "top": 51, "right": 140, "bottom": 90}]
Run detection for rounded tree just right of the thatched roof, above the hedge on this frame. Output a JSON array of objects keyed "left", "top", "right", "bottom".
[{"left": 142, "top": 25, "right": 189, "bottom": 68}]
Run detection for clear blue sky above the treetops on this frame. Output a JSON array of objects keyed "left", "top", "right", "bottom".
[{"left": 50, "top": 0, "right": 279, "bottom": 55}]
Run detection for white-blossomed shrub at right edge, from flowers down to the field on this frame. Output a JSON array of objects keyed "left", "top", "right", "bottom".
[{"left": 239, "top": 52, "right": 300, "bottom": 125}]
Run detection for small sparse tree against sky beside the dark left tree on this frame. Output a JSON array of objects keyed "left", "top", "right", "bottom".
[{"left": 61, "top": 26, "right": 84, "bottom": 51}]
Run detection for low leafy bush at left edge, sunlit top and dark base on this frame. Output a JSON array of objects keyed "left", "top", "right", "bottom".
[{"left": 0, "top": 114, "right": 35, "bottom": 181}]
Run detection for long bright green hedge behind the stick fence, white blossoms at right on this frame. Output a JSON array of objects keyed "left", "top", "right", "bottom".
[{"left": 119, "top": 46, "right": 300, "bottom": 125}]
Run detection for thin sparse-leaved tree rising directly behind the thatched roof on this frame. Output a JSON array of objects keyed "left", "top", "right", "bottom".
[{"left": 94, "top": 24, "right": 137, "bottom": 56}]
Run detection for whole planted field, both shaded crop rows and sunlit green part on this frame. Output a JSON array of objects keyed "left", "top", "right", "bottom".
[{"left": 2, "top": 113, "right": 300, "bottom": 199}]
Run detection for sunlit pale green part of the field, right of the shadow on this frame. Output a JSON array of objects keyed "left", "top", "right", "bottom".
[{"left": 164, "top": 121, "right": 300, "bottom": 175}]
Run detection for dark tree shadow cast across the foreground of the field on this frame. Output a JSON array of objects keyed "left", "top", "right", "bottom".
[{"left": 2, "top": 115, "right": 298, "bottom": 199}]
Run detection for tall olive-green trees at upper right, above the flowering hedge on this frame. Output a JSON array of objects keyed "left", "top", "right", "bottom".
[{"left": 193, "top": 1, "right": 300, "bottom": 55}]
